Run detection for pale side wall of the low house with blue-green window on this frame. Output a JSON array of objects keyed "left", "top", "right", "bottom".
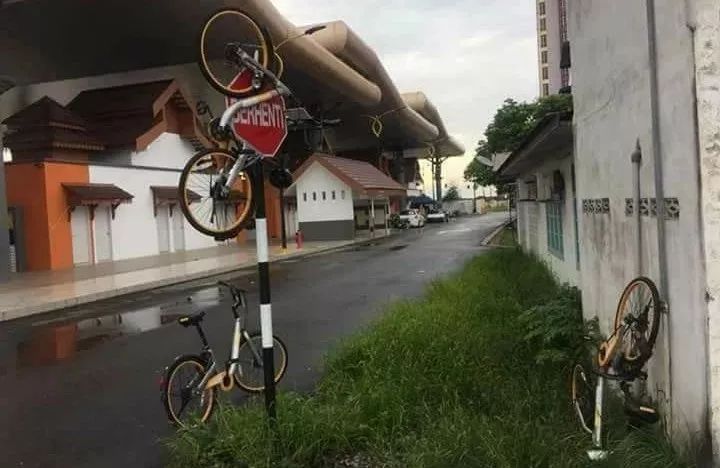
[{"left": 517, "top": 158, "right": 580, "bottom": 286}]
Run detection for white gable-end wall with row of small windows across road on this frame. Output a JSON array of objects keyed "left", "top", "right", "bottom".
[{"left": 296, "top": 163, "right": 354, "bottom": 223}]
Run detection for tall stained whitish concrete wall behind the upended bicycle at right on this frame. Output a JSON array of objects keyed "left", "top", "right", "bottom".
[{"left": 569, "top": 0, "right": 704, "bottom": 444}]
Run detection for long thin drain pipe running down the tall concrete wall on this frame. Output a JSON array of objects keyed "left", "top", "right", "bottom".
[{"left": 647, "top": 0, "right": 673, "bottom": 436}]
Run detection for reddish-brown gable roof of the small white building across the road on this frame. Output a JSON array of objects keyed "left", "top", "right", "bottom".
[{"left": 293, "top": 153, "right": 406, "bottom": 195}]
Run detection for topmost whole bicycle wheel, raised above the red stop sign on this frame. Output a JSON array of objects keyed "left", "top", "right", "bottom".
[{"left": 198, "top": 9, "right": 275, "bottom": 98}]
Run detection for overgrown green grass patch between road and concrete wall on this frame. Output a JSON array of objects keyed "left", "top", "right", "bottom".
[{"left": 167, "top": 249, "right": 690, "bottom": 468}]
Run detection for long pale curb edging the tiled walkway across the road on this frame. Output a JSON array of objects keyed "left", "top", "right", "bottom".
[{"left": 0, "top": 233, "right": 397, "bottom": 322}]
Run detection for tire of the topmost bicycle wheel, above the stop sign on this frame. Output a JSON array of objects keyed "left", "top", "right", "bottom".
[{"left": 198, "top": 8, "right": 277, "bottom": 99}]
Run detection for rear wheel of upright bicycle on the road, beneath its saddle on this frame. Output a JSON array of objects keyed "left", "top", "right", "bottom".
[{"left": 162, "top": 354, "right": 215, "bottom": 427}]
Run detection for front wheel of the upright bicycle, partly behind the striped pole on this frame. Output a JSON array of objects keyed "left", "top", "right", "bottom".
[{"left": 234, "top": 333, "right": 287, "bottom": 393}]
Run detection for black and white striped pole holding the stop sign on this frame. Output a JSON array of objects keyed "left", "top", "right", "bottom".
[{"left": 253, "top": 162, "right": 276, "bottom": 422}]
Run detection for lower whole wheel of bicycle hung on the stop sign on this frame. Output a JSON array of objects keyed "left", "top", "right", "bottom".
[{"left": 179, "top": 149, "right": 255, "bottom": 240}]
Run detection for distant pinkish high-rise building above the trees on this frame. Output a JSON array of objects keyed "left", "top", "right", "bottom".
[{"left": 537, "top": 0, "right": 570, "bottom": 96}]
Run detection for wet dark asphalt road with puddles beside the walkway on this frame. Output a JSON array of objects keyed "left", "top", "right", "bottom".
[{"left": 0, "top": 214, "right": 507, "bottom": 468}]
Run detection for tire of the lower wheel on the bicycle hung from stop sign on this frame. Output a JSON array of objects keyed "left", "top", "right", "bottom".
[{"left": 178, "top": 149, "right": 255, "bottom": 240}]
